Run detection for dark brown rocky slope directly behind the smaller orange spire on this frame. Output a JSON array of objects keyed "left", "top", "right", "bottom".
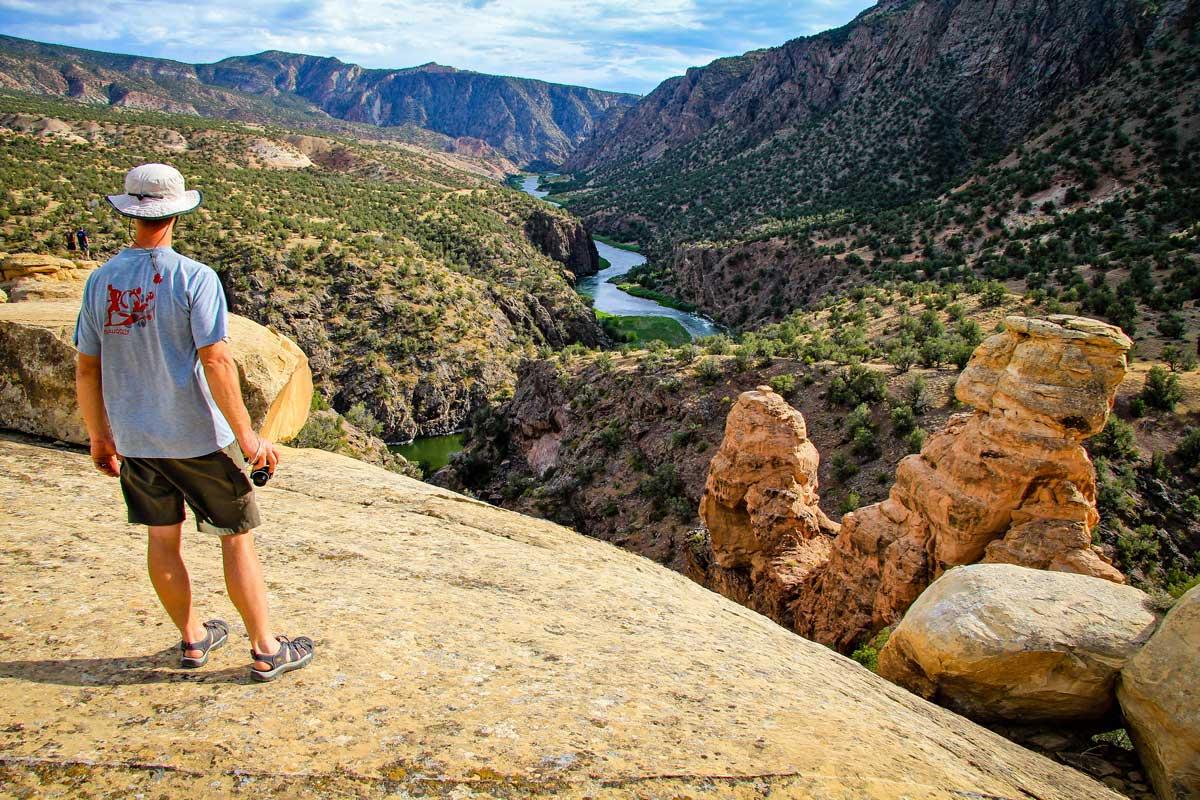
[{"left": 432, "top": 348, "right": 953, "bottom": 571}]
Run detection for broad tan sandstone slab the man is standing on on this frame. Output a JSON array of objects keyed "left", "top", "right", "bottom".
[{"left": 0, "top": 437, "right": 1118, "bottom": 800}]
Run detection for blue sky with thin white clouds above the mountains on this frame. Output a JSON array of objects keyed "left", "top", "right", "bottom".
[{"left": 0, "top": 0, "right": 874, "bottom": 94}]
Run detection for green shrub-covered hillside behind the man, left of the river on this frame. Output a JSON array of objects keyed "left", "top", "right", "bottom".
[{"left": 0, "top": 96, "right": 602, "bottom": 440}]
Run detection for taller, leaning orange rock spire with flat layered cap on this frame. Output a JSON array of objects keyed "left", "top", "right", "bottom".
[{"left": 793, "top": 315, "right": 1130, "bottom": 650}]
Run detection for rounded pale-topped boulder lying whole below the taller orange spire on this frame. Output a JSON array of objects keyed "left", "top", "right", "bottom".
[{"left": 880, "top": 564, "right": 1158, "bottom": 722}]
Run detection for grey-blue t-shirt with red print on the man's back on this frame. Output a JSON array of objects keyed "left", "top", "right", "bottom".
[{"left": 74, "top": 247, "right": 234, "bottom": 458}]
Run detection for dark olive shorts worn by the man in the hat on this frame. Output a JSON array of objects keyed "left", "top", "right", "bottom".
[{"left": 121, "top": 441, "right": 262, "bottom": 536}]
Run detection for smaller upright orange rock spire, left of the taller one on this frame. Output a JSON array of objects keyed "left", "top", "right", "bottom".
[{"left": 700, "top": 386, "right": 838, "bottom": 619}]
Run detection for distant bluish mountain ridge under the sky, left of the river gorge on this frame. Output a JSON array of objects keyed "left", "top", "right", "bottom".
[{"left": 0, "top": 36, "right": 637, "bottom": 169}]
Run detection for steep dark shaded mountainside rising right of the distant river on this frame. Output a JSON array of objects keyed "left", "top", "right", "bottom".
[{"left": 566, "top": 0, "right": 1154, "bottom": 240}]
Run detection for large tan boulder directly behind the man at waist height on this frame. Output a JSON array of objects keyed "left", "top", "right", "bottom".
[{"left": 0, "top": 302, "right": 312, "bottom": 444}]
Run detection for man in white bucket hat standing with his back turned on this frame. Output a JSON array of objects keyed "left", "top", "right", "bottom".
[{"left": 76, "top": 164, "right": 313, "bottom": 680}]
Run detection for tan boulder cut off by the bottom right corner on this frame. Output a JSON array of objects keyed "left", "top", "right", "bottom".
[{"left": 1117, "top": 587, "right": 1200, "bottom": 800}]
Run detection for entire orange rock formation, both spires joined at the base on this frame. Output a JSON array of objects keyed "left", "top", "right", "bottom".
[{"left": 702, "top": 315, "right": 1130, "bottom": 650}]
